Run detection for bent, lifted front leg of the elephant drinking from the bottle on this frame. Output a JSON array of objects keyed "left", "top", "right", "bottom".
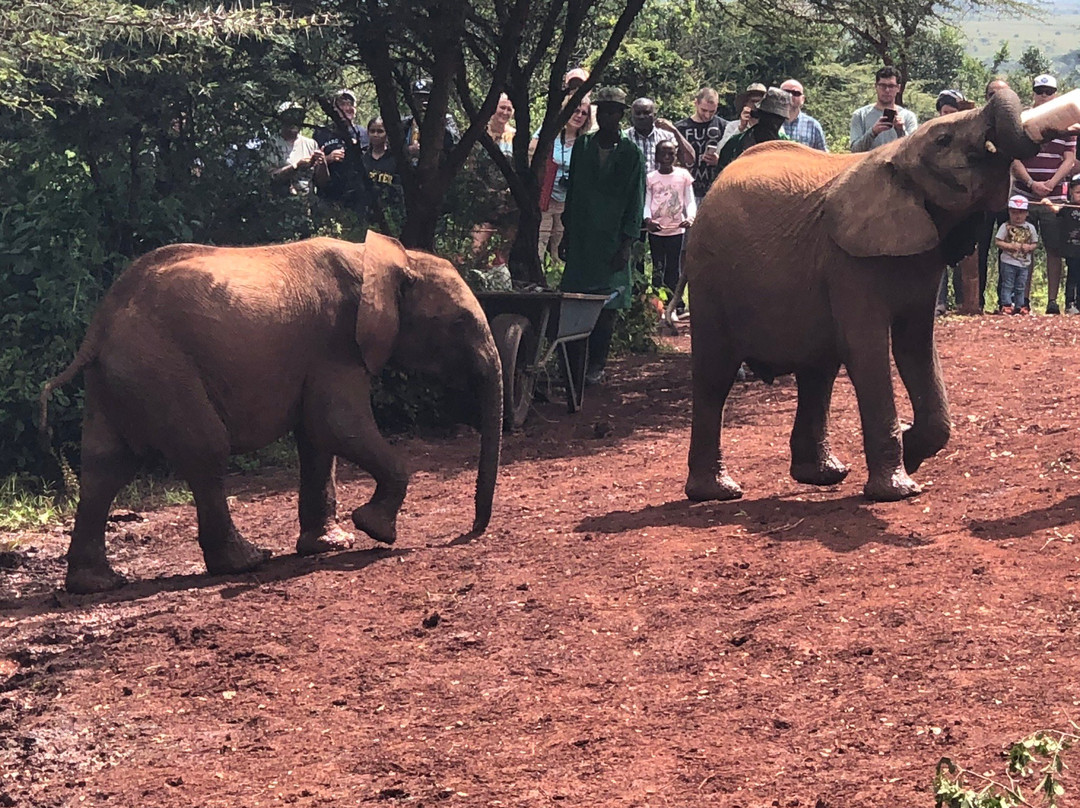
[{"left": 892, "top": 317, "right": 951, "bottom": 474}]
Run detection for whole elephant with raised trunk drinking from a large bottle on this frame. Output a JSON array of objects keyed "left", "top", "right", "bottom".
[{"left": 685, "top": 90, "right": 1080, "bottom": 501}]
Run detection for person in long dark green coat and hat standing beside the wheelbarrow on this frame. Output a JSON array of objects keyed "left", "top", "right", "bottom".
[{"left": 559, "top": 87, "right": 645, "bottom": 385}]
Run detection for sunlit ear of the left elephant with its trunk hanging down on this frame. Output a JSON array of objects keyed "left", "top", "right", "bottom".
[{"left": 356, "top": 230, "right": 411, "bottom": 375}]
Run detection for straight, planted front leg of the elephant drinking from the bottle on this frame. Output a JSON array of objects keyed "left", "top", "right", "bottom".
[{"left": 846, "top": 326, "right": 920, "bottom": 501}]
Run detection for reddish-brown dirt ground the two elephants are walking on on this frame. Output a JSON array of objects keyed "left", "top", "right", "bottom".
[{"left": 0, "top": 317, "right": 1080, "bottom": 808}]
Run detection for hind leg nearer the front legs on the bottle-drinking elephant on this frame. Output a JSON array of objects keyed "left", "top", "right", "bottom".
[{"left": 792, "top": 365, "right": 848, "bottom": 485}]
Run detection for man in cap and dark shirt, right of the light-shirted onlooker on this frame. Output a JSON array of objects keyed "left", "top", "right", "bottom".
[{"left": 314, "top": 89, "right": 368, "bottom": 211}]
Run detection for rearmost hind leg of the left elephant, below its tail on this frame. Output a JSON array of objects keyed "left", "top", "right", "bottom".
[{"left": 64, "top": 372, "right": 137, "bottom": 594}]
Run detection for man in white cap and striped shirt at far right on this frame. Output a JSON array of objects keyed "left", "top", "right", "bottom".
[{"left": 1012, "top": 73, "right": 1077, "bottom": 314}]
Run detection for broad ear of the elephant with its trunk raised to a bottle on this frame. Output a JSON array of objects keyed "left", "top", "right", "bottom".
[{"left": 824, "top": 147, "right": 941, "bottom": 258}]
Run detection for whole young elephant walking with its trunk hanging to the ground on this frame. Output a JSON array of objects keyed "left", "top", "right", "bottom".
[{"left": 41, "top": 232, "right": 502, "bottom": 593}]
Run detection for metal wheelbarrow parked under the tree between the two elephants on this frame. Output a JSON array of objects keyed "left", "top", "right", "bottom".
[{"left": 476, "top": 292, "right": 619, "bottom": 430}]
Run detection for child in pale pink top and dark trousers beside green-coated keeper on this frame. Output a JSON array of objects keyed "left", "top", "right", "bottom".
[{"left": 645, "top": 140, "right": 698, "bottom": 313}]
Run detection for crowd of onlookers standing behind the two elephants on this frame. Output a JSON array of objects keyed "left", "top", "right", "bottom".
[{"left": 272, "top": 66, "right": 1080, "bottom": 383}]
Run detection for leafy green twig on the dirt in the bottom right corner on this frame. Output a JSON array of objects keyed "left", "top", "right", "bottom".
[{"left": 934, "top": 730, "right": 1080, "bottom": 808}]
